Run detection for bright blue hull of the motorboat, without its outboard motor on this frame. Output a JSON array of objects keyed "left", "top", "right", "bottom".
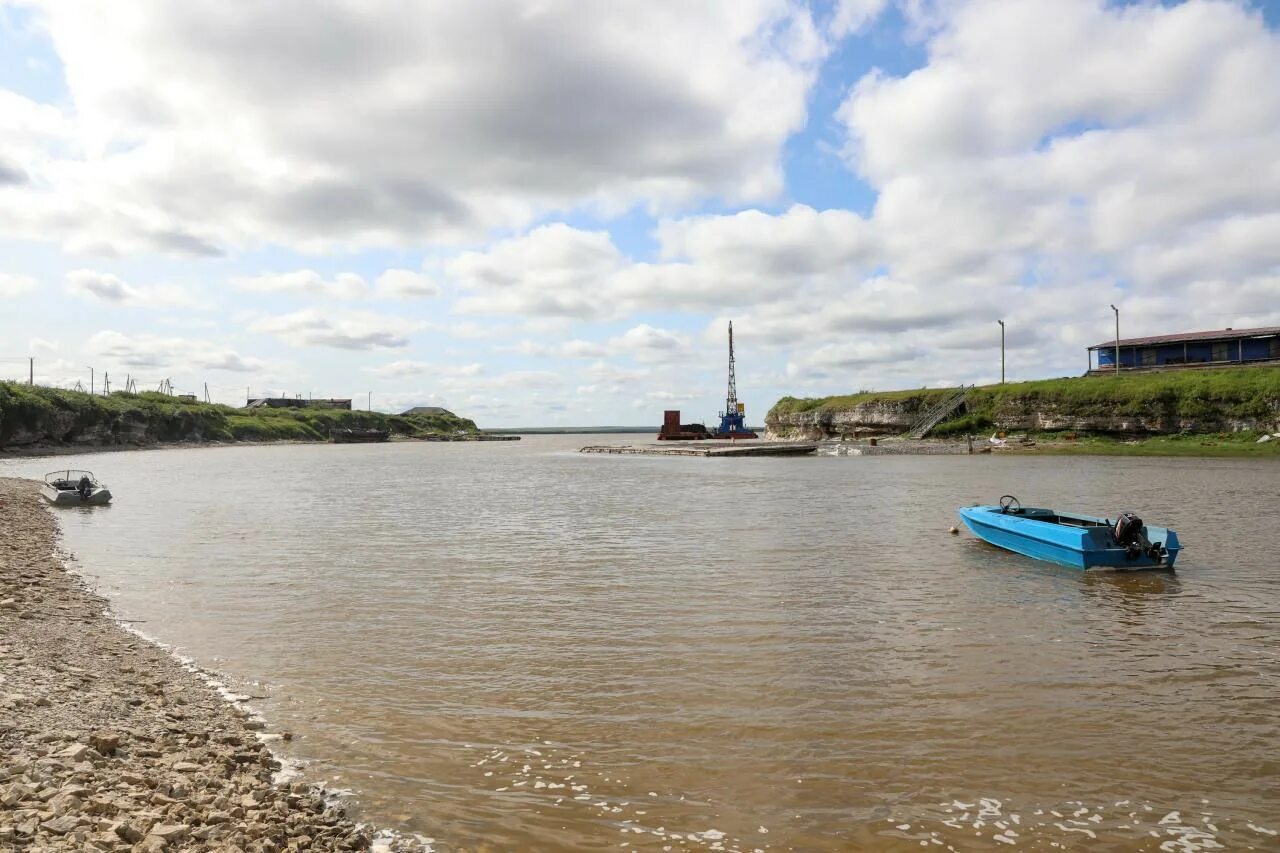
[{"left": 960, "top": 506, "right": 1181, "bottom": 570}]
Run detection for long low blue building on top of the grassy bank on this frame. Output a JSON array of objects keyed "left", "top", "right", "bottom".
[{"left": 1089, "top": 325, "right": 1280, "bottom": 373}]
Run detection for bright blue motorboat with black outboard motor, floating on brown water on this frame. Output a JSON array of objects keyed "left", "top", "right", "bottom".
[{"left": 960, "top": 494, "right": 1181, "bottom": 569}]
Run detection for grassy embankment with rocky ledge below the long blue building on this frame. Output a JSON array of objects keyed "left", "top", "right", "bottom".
[{"left": 769, "top": 368, "right": 1280, "bottom": 457}]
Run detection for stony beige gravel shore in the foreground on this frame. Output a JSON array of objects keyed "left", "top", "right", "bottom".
[{"left": 0, "top": 478, "right": 422, "bottom": 852}]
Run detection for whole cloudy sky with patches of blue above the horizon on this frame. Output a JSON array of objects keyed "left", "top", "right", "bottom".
[{"left": 0, "top": 0, "right": 1280, "bottom": 427}]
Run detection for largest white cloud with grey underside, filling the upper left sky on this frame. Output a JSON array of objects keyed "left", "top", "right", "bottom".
[{"left": 5, "top": 0, "right": 827, "bottom": 255}]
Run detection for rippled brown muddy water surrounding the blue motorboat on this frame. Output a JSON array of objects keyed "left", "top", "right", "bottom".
[{"left": 0, "top": 435, "right": 1280, "bottom": 850}]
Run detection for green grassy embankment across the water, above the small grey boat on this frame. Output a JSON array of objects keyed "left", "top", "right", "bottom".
[{"left": 0, "top": 382, "right": 479, "bottom": 448}]
